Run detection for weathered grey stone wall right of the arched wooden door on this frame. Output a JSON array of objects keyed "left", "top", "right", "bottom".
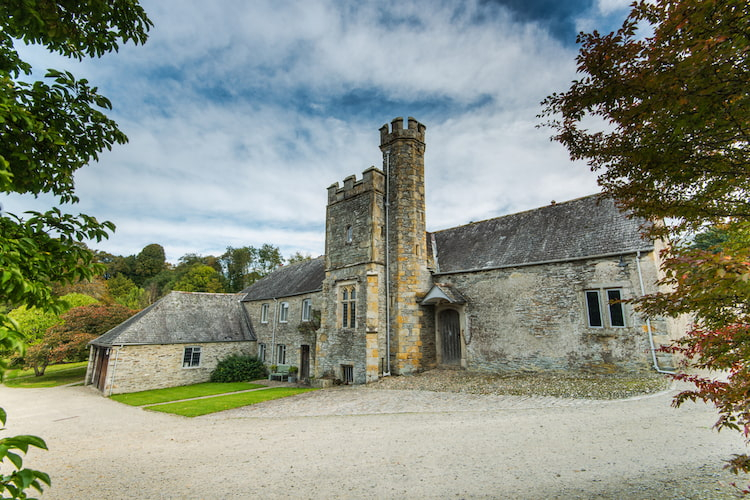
[{"left": 439, "top": 254, "right": 669, "bottom": 372}]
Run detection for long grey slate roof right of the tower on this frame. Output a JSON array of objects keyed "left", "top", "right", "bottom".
[{"left": 433, "top": 195, "right": 653, "bottom": 273}]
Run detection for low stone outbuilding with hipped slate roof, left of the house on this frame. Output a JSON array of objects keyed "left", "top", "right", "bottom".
[{"left": 85, "top": 292, "right": 256, "bottom": 395}]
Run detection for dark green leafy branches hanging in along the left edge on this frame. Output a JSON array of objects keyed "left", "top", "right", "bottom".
[{"left": 0, "top": 0, "right": 151, "bottom": 498}]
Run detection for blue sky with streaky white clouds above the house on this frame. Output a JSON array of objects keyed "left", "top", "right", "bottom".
[{"left": 5, "top": 0, "right": 630, "bottom": 262}]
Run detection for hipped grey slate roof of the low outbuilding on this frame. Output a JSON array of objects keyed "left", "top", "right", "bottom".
[{"left": 90, "top": 292, "right": 255, "bottom": 346}]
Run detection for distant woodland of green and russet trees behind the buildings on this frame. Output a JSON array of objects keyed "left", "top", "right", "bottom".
[{"left": 0, "top": 243, "right": 311, "bottom": 375}]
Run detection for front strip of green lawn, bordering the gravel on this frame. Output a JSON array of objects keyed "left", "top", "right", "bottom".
[{"left": 146, "top": 387, "right": 316, "bottom": 417}]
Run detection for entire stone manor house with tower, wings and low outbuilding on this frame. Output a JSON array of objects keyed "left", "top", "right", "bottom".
[{"left": 86, "top": 118, "right": 684, "bottom": 394}]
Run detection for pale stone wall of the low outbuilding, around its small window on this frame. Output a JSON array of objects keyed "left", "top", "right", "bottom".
[{"left": 103, "top": 341, "right": 256, "bottom": 395}]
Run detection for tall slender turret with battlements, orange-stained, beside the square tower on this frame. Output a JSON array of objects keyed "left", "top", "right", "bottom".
[{"left": 380, "top": 117, "right": 435, "bottom": 374}]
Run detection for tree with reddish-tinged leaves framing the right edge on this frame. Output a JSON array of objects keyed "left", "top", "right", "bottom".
[{"left": 542, "top": 0, "right": 750, "bottom": 488}]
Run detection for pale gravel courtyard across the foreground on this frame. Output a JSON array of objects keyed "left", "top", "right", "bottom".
[{"left": 0, "top": 377, "right": 746, "bottom": 500}]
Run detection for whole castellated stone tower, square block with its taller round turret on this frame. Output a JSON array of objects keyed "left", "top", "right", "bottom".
[{"left": 315, "top": 118, "right": 435, "bottom": 383}]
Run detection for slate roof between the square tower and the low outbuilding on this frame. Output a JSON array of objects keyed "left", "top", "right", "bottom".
[{"left": 241, "top": 257, "right": 326, "bottom": 302}]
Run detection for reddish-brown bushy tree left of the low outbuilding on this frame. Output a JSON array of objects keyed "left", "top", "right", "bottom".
[{"left": 24, "top": 304, "right": 136, "bottom": 376}]
